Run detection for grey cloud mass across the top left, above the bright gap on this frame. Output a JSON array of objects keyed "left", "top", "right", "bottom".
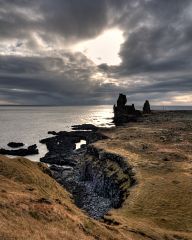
[{"left": 0, "top": 0, "right": 126, "bottom": 41}]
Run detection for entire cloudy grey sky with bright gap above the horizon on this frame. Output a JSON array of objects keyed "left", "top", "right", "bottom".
[{"left": 0, "top": 0, "right": 192, "bottom": 105}]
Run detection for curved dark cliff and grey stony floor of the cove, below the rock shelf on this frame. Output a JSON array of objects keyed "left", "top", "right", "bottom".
[{"left": 50, "top": 146, "right": 136, "bottom": 219}]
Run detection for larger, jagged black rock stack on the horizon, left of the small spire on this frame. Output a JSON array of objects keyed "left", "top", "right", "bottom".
[{"left": 113, "top": 93, "right": 141, "bottom": 125}]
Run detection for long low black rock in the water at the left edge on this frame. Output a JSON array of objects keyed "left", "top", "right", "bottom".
[{"left": 0, "top": 144, "right": 39, "bottom": 156}]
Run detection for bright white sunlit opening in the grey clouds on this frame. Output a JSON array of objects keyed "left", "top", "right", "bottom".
[{"left": 73, "top": 28, "right": 124, "bottom": 65}]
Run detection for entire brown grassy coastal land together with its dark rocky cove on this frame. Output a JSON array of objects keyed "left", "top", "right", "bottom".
[{"left": 0, "top": 107, "right": 192, "bottom": 240}]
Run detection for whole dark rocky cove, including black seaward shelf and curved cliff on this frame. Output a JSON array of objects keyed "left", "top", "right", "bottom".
[{"left": 40, "top": 124, "right": 136, "bottom": 219}]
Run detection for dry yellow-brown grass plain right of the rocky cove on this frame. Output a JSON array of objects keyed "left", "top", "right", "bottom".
[{"left": 95, "top": 112, "right": 192, "bottom": 239}]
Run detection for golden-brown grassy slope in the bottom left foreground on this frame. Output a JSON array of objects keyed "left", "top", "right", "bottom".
[{"left": 0, "top": 156, "right": 121, "bottom": 240}]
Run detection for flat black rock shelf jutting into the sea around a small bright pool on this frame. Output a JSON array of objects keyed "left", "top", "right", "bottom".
[{"left": 40, "top": 124, "right": 107, "bottom": 167}]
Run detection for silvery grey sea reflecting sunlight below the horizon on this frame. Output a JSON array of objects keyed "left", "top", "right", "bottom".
[{"left": 0, "top": 105, "right": 192, "bottom": 161}]
